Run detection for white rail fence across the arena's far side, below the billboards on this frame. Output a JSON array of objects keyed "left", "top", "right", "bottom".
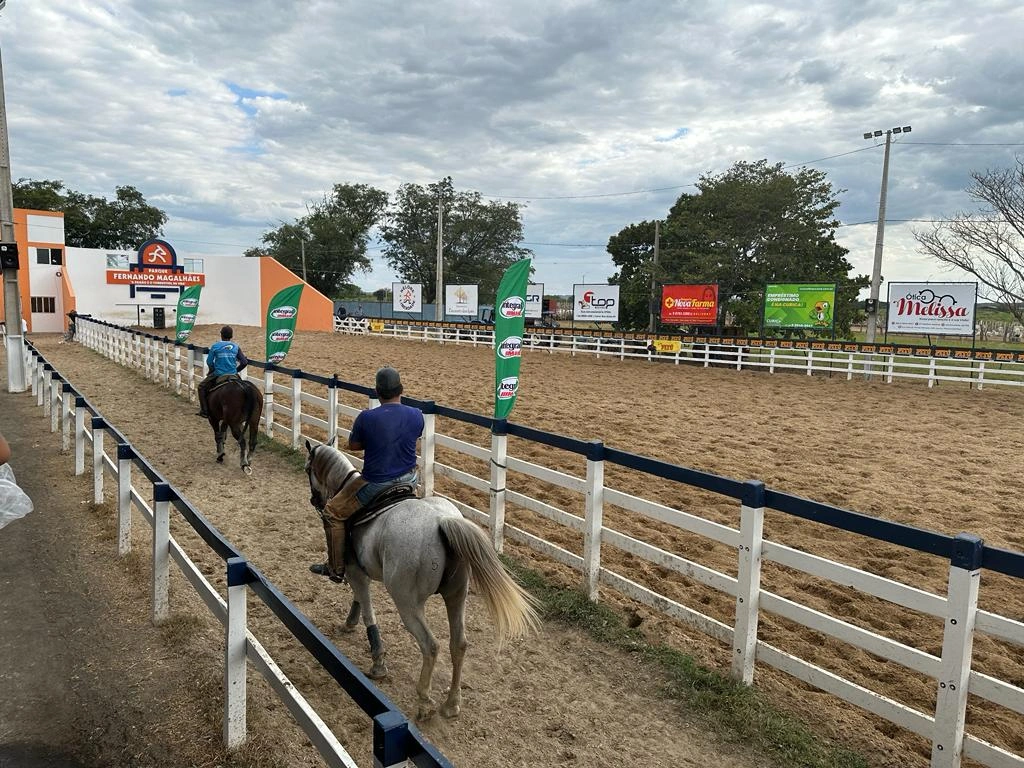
[{"left": 334, "top": 317, "right": 1024, "bottom": 389}]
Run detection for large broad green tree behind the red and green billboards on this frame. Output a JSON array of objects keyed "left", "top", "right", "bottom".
[{"left": 608, "top": 160, "right": 869, "bottom": 334}]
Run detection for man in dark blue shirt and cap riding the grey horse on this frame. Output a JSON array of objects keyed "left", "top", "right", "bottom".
[{"left": 309, "top": 368, "right": 423, "bottom": 582}]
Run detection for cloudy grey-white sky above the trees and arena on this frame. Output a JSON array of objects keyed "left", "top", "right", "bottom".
[{"left": 0, "top": 0, "right": 1024, "bottom": 295}]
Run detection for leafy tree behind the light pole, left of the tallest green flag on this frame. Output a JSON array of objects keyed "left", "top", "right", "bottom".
[{"left": 381, "top": 176, "right": 531, "bottom": 303}]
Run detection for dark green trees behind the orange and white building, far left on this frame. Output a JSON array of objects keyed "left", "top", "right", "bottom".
[{"left": 11, "top": 178, "right": 167, "bottom": 250}]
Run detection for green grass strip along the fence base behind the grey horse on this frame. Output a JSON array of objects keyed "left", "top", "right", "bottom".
[{"left": 502, "top": 557, "right": 869, "bottom": 768}]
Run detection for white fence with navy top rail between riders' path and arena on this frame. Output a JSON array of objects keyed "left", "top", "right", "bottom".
[{"left": 72, "top": 313, "right": 1024, "bottom": 768}]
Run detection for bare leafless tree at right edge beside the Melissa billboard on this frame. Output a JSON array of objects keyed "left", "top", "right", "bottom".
[{"left": 913, "top": 158, "right": 1024, "bottom": 323}]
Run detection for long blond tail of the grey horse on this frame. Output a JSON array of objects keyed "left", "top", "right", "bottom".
[{"left": 440, "top": 516, "right": 541, "bottom": 643}]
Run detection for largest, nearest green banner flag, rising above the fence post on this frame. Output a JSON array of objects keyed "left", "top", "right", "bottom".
[{"left": 495, "top": 259, "right": 529, "bottom": 419}]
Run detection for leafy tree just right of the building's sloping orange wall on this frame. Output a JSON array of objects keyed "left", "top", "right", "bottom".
[{"left": 245, "top": 184, "right": 388, "bottom": 299}]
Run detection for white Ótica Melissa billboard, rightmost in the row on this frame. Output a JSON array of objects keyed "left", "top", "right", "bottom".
[{"left": 886, "top": 283, "right": 978, "bottom": 336}]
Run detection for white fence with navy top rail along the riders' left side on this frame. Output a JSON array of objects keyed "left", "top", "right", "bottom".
[{"left": 18, "top": 339, "right": 452, "bottom": 768}]
